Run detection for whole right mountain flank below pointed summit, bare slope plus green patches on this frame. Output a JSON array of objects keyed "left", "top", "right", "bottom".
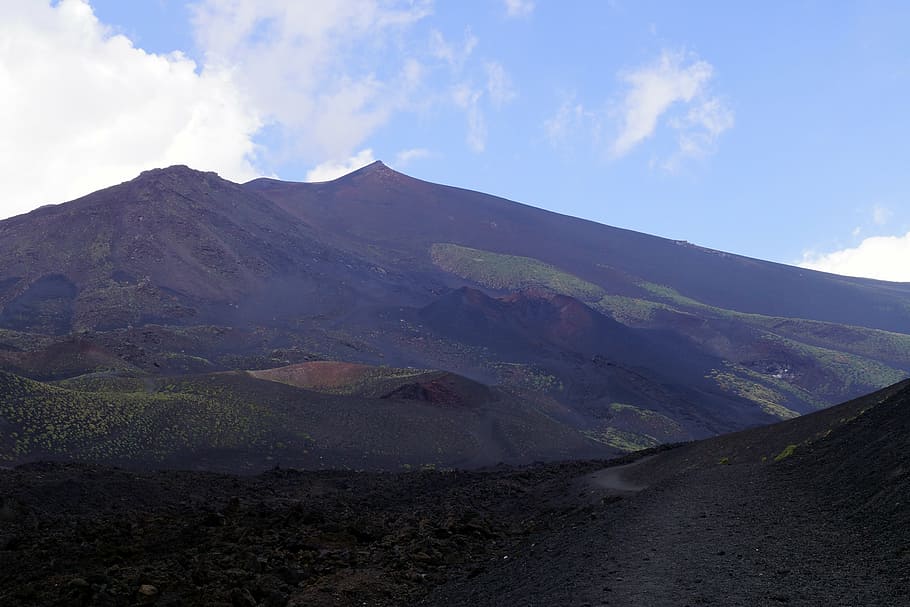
[{"left": 245, "top": 163, "right": 910, "bottom": 430}]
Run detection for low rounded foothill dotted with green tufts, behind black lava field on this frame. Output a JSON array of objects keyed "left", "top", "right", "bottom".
[{"left": 0, "top": 363, "right": 617, "bottom": 474}]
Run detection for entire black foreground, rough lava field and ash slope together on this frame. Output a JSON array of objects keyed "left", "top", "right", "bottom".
[{"left": 0, "top": 382, "right": 910, "bottom": 607}]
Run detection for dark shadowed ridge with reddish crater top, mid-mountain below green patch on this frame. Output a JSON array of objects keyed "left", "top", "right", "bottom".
[{"left": 420, "top": 288, "right": 792, "bottom": 440}]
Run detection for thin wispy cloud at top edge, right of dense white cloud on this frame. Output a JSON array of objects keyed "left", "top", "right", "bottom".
[{"left": 193, "top": 0, "right": 430, "bottom": 160}]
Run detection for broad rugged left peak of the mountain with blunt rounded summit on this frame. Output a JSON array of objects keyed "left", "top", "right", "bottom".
[{"left": 0, "top": 167, "right": 416, "bottom": 334}]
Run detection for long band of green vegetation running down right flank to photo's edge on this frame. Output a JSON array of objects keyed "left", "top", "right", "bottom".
[{"left": 430, "top": 243, "right": 910, "bottom": 404}]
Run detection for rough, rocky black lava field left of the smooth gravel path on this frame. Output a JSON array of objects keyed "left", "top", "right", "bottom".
[{"left": 0, "top": 462, "right": 620, "bottom": 607}]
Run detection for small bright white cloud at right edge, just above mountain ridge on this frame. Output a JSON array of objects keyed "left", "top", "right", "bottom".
[{"left": 797, "top": 232, "right": 910, "bottom": 282}]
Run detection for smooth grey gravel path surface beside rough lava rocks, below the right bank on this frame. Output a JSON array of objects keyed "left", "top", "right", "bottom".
[{"left": 427, "top": 456, "right": 910, "bottom": 607}]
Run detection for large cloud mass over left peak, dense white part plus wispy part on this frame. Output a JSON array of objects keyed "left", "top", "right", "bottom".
[{"left": 0, "top": 0, "right": 516, "bottom": 218}]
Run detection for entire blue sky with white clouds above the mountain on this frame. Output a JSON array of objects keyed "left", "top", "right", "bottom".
[{"left": 0, "top": 0, "right": 910, "bottom": 281}]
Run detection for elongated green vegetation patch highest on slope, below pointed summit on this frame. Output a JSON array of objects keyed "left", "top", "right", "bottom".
[{"left": 430, "top": 243, "right": 605, "bottom": 302}]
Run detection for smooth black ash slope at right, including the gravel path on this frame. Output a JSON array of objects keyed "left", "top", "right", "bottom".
[{"left": 423, "top": 382, "right": 910, "bottom": 607}]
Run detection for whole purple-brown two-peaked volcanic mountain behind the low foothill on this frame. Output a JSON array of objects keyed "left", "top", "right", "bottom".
[{"left": 0, "top": 162, "right": 910, "bottom": 469}]
